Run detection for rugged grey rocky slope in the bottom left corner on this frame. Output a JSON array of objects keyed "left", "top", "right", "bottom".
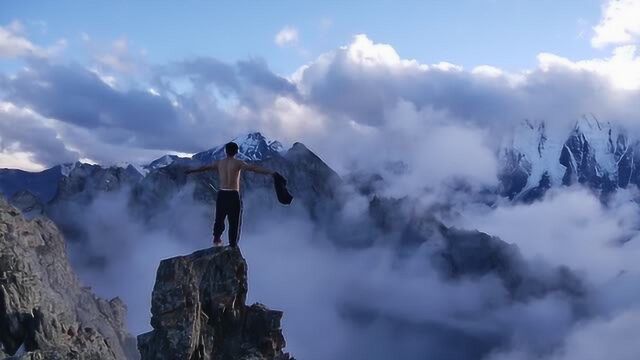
[{"left": 0, "top": 198, "right": 139, "bottom": 360}]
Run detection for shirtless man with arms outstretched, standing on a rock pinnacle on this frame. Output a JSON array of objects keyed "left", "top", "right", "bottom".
[{"left": 186, "top": 142, "right": 274, "bottom": 247}]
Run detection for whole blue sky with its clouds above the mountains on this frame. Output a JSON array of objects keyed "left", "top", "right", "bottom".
[{"left": 0, "top": 0, "right": 640, "bottom": 172}]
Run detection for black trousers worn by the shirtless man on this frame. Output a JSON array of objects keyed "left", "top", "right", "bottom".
[{"left": 213, "top": 190, "right": 242, "bottom": 247}]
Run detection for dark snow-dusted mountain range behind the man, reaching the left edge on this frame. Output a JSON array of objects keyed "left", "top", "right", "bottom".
[{"left": 0, "top": 133, "right": 339, "bottom": 220}]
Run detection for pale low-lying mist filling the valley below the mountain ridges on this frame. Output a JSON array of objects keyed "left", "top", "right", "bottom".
[{"left": 52, "top": 174, "right": 640, "bottom": 360}]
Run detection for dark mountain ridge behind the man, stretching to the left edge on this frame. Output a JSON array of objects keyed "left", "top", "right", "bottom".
[{"left": 0, "top": 133, "right": 342, "bottom": 241}]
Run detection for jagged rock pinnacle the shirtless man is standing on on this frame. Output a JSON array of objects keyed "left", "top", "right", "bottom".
[{"left": 138, "top": 247, "right": 292, "bottom": 360}]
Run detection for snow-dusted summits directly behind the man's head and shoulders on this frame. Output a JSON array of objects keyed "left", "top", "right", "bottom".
[{"left": 192, "top": 132, "right": 283, "bottom": 163}]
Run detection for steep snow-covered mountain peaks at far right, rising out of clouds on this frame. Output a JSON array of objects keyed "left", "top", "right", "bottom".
[{"left": 499, "top": 115, "right": 640, "bottom": 200}]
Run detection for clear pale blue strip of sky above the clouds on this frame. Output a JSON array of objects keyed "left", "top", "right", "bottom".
[{"left": 0, "top": 0, "right": 602, "bottom": 74}]
